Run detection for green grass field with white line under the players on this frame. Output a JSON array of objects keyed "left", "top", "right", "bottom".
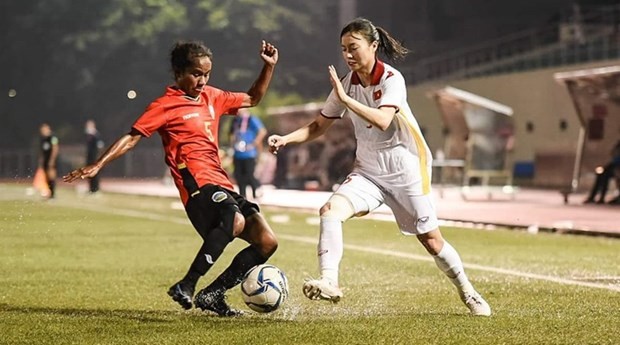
[{"left": 0, "top": 184, "right": 620, "bottom": 344}]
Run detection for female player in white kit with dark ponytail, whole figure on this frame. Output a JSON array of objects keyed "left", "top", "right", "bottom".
[{"left": 268, "top": 18, "right": 491, "bottom": 316}]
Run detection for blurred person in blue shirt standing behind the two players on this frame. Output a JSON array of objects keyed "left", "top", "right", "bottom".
[{"left": 230, "top": 108, "right": 267, "bottom": 199}]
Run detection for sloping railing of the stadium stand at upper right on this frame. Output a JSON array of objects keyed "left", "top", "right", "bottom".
[{"left": 402, "top": 5, "right": 620, "bottom": 83}]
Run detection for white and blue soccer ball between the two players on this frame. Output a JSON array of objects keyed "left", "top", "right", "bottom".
[{"left": 241, "top": 264, "right": 288, "bottom": 313}]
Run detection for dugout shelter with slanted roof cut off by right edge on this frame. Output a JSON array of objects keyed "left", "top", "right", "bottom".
[{"left": 554, "top": 65, "right": 620, "bottom": 203}]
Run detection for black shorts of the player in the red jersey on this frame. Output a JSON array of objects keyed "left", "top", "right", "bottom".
[{"left": 185, "top": 184, "right": 260, "bottom": 238}]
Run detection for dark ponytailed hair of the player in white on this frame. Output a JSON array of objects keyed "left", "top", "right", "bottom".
[{"left": 340, "top": 17, "right": 409, "bottom": 61}]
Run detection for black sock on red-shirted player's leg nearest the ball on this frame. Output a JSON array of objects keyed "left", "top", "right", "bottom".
[{"left": 207, "top": 246, "right": 268, "bottom": 291}]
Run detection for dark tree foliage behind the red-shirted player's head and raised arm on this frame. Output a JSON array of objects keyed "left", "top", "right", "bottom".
[{"left": 0, "top": 0, "right": 337, "bottom": 146}]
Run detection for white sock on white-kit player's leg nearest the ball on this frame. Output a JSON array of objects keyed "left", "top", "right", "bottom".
[{"left": 318, "top": 217, "right": 343, "bottom": 285}]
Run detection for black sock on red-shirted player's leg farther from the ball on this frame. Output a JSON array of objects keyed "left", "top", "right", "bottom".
[{"left": 183, "top": 228, "right": 231, "bottom": 288}]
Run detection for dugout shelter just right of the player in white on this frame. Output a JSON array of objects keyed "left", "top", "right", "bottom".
[{"left": 427, "top": 86, "right": 515, "bottom": 199}]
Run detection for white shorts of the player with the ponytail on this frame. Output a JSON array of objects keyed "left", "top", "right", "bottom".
[{"left": 334, "top": 173, "right": 439, "bottom": 235}]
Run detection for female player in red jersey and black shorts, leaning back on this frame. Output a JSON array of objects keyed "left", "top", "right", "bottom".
[{"left": 64, "top": 41, "right": 278, "bottom": 316}]
